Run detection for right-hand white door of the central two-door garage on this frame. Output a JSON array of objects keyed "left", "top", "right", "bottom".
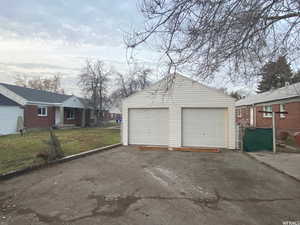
[{"left": 182, "top": 108, "right": 225, "bottom": 147}]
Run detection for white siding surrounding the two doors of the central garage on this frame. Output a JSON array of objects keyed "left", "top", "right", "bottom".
[{"left": 122, "top": 75, "right": 235, "bottom": 149}]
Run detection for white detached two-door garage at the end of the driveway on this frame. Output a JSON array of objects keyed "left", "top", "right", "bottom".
[{"left": 122, "top": 74, "right": 235, "bottom": 149}]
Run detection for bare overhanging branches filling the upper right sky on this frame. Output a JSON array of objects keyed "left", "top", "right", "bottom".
[{"left": 125, "top": 0, "right": 300, "bottom": 79}]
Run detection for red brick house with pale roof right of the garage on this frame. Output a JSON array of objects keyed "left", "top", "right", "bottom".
[{"left": 236, "top": 83, "right": 300, "bottom": 135}]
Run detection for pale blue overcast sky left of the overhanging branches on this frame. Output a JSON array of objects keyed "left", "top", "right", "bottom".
[{"left": 0, "top": 0, "right": 258, "bottom": 95}]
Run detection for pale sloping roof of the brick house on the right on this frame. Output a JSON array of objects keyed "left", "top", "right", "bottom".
[{"left": 235, "top": 82, "right": 300, "bottom": 106}]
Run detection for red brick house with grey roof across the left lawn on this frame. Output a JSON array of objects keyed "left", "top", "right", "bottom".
[{"left": 0, "top": 83, "right": 109, "bottom": 133}]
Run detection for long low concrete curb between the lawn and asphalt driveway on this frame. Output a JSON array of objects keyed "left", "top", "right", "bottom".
[{"left": 0, "top": 143, "right": 122, "bottom": 181}]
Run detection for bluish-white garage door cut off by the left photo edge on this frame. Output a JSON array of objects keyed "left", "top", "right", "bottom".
[{"left": 0, "top": 106, "right": 23, "bottom": 135}]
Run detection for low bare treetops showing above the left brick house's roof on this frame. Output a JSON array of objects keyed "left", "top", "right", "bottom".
[{"left": 15, "top": 74, "right": 65, "bottom": 94}]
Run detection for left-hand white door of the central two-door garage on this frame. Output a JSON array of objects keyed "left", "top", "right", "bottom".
[{"left": 129, "top": 109, "right": 169, "bottom": 145}]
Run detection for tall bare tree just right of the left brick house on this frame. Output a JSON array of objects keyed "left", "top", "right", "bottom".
[{"left": 79, "top": 60, "right": 111, "bottom": 124}]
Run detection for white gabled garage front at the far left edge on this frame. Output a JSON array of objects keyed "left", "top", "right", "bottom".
[{"left": 0, "top": 94, "right": 23, "bottom": 135}]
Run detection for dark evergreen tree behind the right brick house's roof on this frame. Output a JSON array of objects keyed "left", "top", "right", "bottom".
[{"left": 257, "top": 56, "right": 293, "bottom": 93}]
